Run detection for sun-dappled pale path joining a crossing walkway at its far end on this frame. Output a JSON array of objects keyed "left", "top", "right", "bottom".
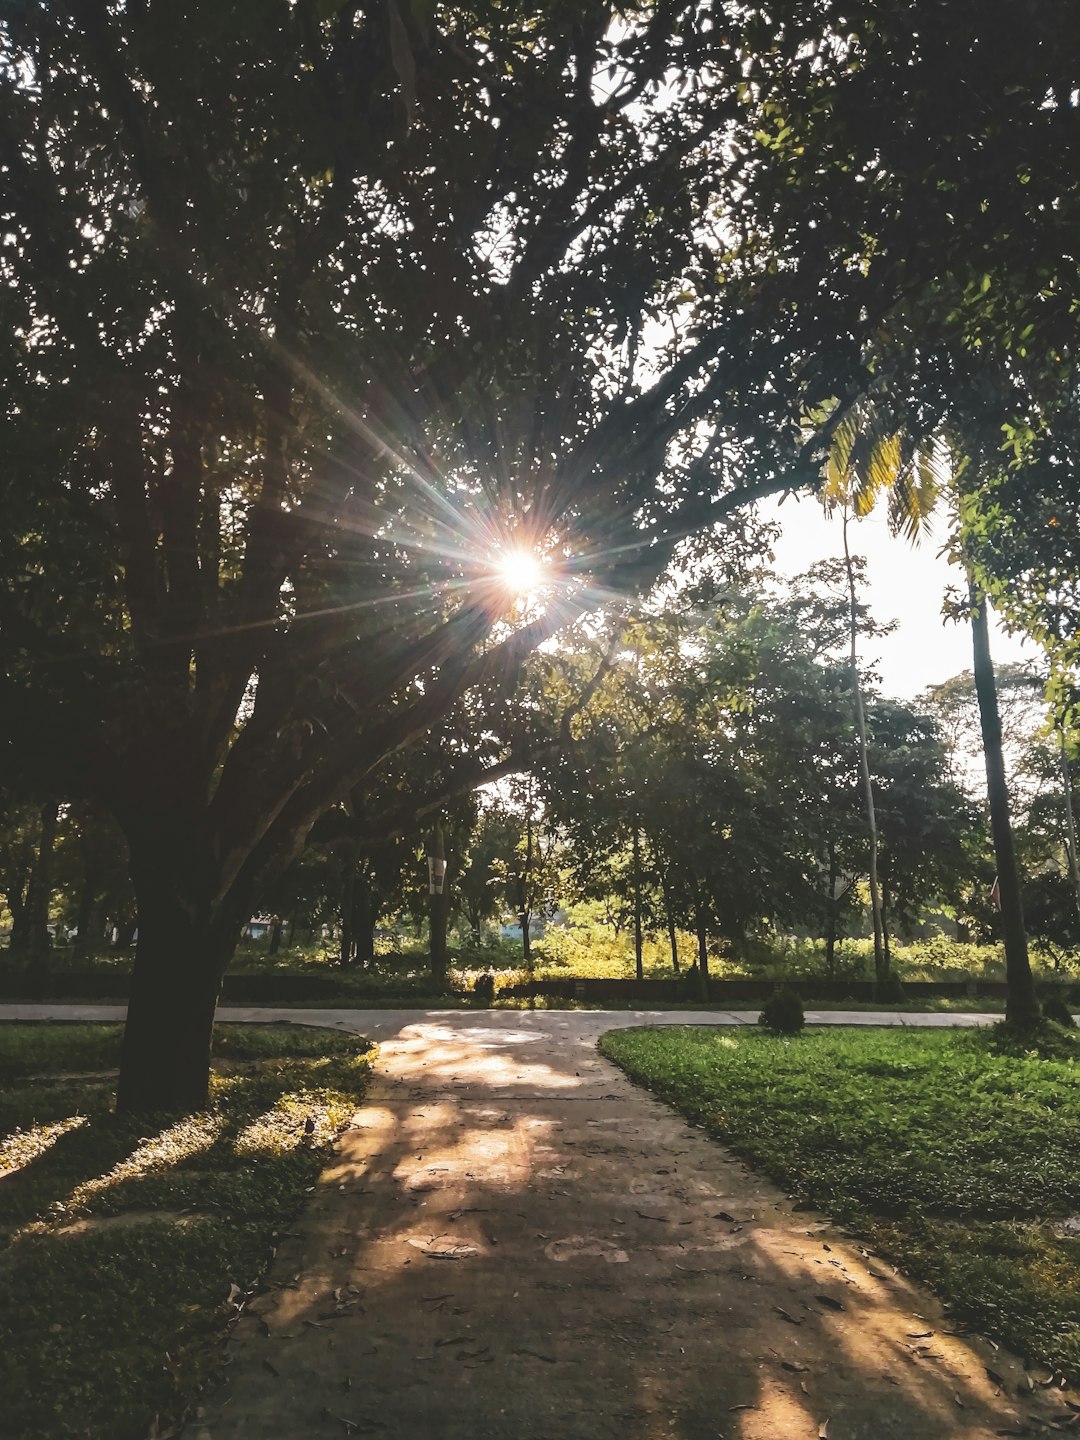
[{"left": 0, "top": 1007, "right": 1060, "bottom": 1440}]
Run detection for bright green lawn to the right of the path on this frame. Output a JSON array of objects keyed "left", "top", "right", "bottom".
[{"left": 600, "top": 1030, "right": 1080, "bottom": 1377}]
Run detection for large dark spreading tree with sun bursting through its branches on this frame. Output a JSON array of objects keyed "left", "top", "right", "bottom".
[{"left": 0, "top": 0, "right": 1071, "bottom": 1109}]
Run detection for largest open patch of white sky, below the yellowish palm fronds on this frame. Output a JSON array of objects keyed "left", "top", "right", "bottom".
[{"left": 759, "top": 495, "right": 1030, "bottom": 700}]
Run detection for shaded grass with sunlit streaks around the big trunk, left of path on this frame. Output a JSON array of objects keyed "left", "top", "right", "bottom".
[{"left": 0, "top": 1025, "right": 369, "bottom": 1440}]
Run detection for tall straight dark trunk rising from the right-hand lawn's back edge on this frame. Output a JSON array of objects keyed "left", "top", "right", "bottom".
[{"left": 968, "top": 577, "right": 1040, "bottom": 1025}]
